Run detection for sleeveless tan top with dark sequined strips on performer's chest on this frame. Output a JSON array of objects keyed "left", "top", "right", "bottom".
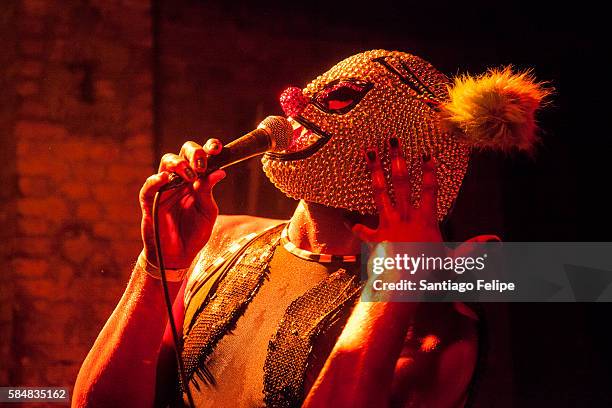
[{"left": 183, "top": 225, "right": 486, "bottom": 407}]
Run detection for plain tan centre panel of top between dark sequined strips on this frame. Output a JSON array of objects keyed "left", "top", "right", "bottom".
[{"left": 192, "top": 241, "right": 356, "bottom": 407}]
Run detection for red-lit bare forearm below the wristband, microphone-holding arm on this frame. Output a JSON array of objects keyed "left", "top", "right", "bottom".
[{"left": 73, "top": 269, "right": 180, "bottom": 407}]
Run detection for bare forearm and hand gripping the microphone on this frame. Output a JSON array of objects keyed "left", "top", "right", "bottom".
[{"left": 72, "top": 141, "right": 224, "bottom": 407}]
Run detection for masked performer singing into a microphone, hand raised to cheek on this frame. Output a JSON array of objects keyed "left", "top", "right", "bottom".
[{"left": 73, "top": 50, "right": 548, "bottom": 407}]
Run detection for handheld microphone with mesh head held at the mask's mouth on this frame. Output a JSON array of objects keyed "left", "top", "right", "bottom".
[{"left": 159, "top": 116, "right": 293, "bottom": 192}]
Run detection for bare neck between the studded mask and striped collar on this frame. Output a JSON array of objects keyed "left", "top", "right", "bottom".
[{"left": 288, "top": 201, "right": 361, "bottom": 255}]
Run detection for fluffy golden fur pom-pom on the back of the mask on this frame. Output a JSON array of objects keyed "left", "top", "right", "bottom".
[{"left": 441, "top": 67, "right": 551, "bottom": 152}]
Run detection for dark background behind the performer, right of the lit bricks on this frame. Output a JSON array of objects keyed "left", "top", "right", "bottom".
[{"left": 155, "top": 0, "right": 612, "bottom": 407}]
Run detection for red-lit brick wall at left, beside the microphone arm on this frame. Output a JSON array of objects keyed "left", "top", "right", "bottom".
[{"left": 5, "top": 0, "right": 153, "bottom": 386}]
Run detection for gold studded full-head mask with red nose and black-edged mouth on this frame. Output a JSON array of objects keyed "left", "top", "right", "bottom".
[{"left": 262, "top": 50, "right": 470, "bottom": 219}]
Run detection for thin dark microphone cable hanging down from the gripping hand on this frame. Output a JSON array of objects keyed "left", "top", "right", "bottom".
[{"left": 153, "top": 190, "right": 195, "bottom": 408}]
